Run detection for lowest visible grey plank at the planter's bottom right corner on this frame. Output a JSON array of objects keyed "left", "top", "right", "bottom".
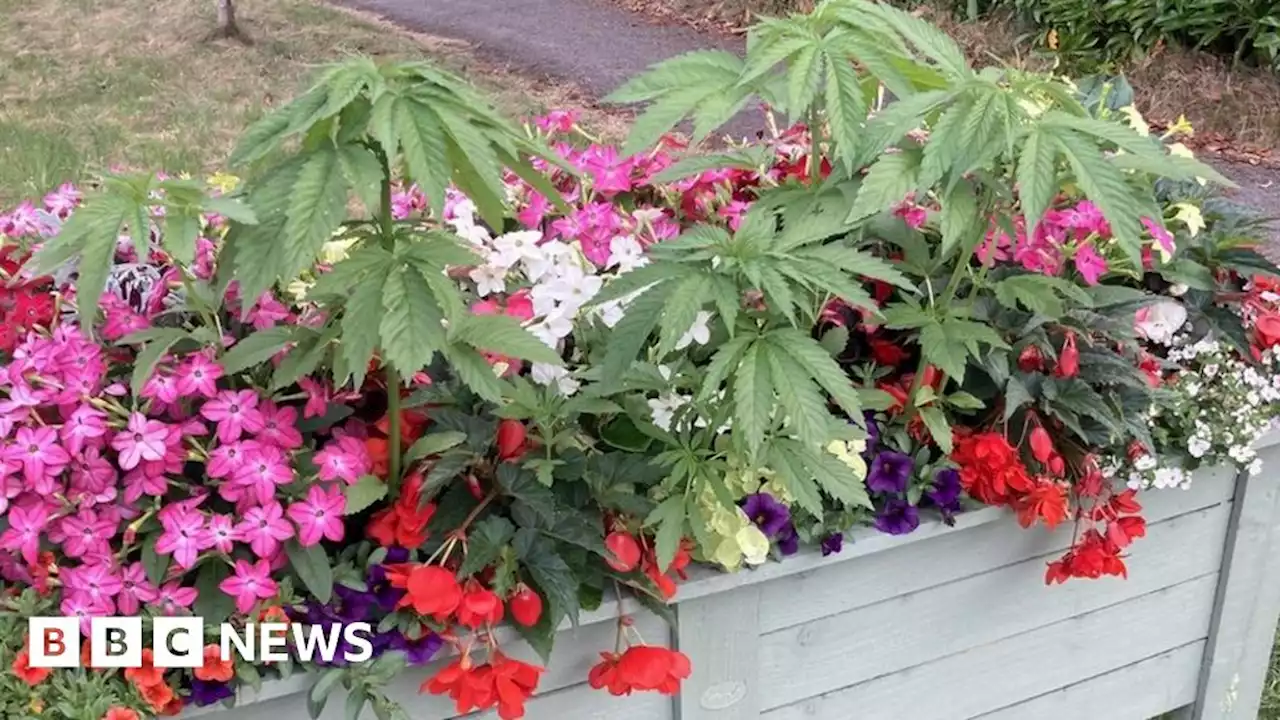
[{"left": 980, "top": 641, "right": 1204, "bottom": 720}]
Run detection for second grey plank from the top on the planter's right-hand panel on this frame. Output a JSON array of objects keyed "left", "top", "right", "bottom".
[{"left": 759, "top": 505, "right": 1230, "bottom": 710}]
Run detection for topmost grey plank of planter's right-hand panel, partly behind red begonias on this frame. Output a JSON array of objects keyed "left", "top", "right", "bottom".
[{"left": 760, "top": 471, "right": 1234, "bottom": 633}]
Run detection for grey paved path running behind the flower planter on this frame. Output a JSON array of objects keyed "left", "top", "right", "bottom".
[{"left": 335, "top": 0, "right": 1280, "bottom": 242}]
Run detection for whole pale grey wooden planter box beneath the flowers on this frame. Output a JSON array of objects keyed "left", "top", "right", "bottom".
[{"left": 191, "top": 437, "right": 1280, "bottom": 720}]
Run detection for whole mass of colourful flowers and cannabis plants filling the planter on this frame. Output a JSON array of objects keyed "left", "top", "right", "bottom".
[{"left": 0, "top": 0, "right": 1280, "bottom": 720}]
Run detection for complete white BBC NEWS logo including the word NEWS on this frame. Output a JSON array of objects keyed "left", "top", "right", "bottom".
[{"left": 27, "top": 618, "right": 374, "bottom": 667}]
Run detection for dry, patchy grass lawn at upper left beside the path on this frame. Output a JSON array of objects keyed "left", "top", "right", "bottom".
[{"left": 0, "top": 0, "right": 617, "bottom": 209}]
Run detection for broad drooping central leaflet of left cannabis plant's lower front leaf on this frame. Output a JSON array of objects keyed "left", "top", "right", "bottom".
[{"left": 378, "top": 265, "right": 445, "bottom": 375}]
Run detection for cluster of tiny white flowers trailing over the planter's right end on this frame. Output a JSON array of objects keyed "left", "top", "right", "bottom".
[{"left": 1102, "top": 336, "right": 1280, "bottom": 489}]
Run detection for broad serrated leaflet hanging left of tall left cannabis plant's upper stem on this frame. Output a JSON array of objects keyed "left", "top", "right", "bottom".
[{"left": 278, "top": 145, "right": 347, "bottom": 278}]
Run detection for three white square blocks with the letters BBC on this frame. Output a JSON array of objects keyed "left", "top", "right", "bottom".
[{"left": 27, "top": 618, "right": 205, "bottom": 667}]
